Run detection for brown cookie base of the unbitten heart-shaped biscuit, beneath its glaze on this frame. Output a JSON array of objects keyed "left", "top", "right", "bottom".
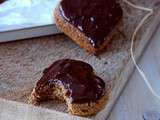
[{"left": 54, "top": 5, "right": 122, "bottom": 54}]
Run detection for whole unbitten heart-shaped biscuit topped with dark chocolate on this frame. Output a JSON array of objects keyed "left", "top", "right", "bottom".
[{"left": 54, "top": 0, "right": 122, "bottom": 53}]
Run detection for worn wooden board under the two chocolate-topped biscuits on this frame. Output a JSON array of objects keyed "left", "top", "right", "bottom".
[{"left": 0, "top": 0, "right": 160, "bottom": 120}]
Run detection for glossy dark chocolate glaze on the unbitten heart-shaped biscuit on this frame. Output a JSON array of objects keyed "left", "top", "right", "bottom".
[{"left": 60, "top": 0, "right": 122, "bottom": 48}]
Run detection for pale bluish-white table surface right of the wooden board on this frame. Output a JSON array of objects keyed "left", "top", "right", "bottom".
[{"left": 109, "top": 23, "right": 160, "bottom": 120}]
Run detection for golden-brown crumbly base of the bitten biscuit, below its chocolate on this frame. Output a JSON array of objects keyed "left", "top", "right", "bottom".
[{"left": 29, "top": 87, "right": 108, "bottom": 116}]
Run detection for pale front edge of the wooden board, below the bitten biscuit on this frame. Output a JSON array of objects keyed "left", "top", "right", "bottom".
[{"left": 0, "top": 98, "right": 89, "bottom": 120}]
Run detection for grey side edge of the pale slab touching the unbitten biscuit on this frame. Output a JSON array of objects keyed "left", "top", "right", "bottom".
[{"left": 0, "top": 24, "right": 61, "bottom": 43}]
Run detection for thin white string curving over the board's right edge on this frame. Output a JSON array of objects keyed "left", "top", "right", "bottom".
[{"left": 123, "top": 0, "right": 160, "bottom": 100}]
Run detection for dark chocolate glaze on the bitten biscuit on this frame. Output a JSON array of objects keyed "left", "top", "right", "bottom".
[{"left": 36, "top": 59, "right": 105, "bottom": 103}]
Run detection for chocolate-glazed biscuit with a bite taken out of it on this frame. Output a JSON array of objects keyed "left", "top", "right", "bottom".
[{"left": 29, "top": 59, "right": 108, "bottom": 116}]
